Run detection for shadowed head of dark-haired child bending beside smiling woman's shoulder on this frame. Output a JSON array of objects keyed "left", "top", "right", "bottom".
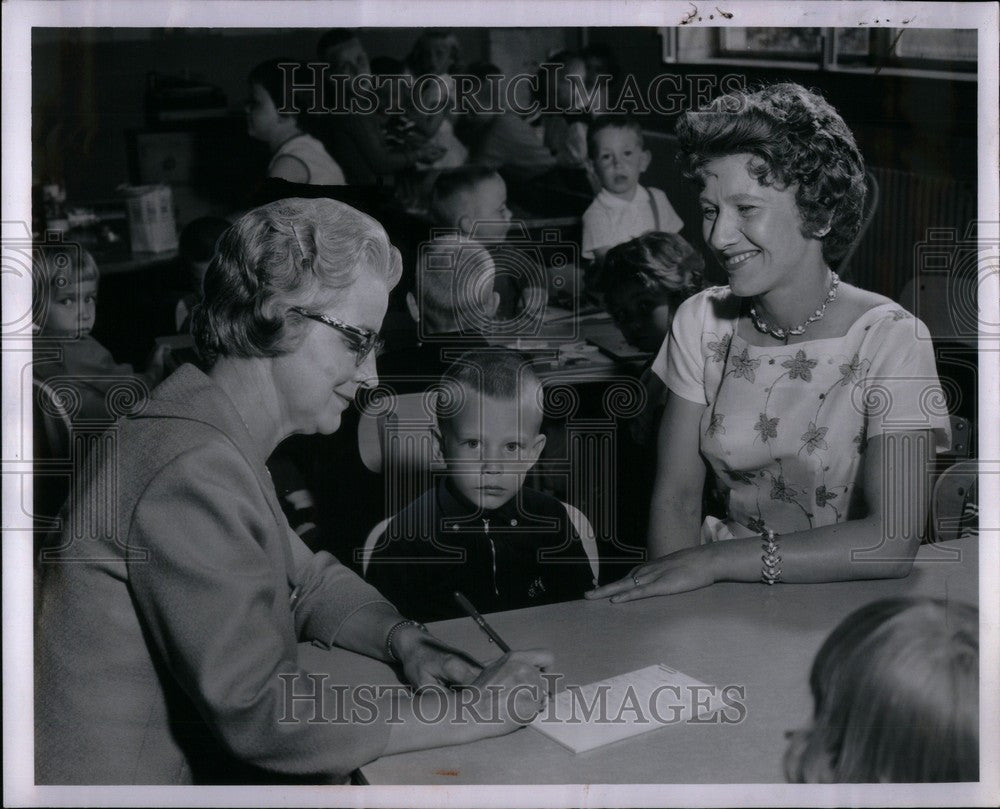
[{"left": 600, "top": 232, "right": 705, "bottom": 353}]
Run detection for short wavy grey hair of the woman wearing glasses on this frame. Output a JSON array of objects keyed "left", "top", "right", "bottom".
[{"left": 192, "top": 199, "right": 402, "bottom": 366}]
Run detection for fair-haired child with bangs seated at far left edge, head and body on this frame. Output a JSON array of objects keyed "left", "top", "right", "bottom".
[{"left": 32, "top": 244, "right": 167, "bottom": 422}]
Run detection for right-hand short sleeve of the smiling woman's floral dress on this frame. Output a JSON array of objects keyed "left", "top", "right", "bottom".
[{"left": 860, "top": 309, "right": 951, "bottom": 452}]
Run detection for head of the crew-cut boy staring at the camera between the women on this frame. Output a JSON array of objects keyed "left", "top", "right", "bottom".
[{"left": 437, "top": 349, "right": 545, "bottom": 510}]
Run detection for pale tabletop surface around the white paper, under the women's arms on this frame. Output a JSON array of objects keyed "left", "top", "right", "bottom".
[{"left": 303, "top": 540, "right": 978, "bottom": 784}]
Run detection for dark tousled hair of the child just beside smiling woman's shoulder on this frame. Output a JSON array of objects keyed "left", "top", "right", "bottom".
[{"left": 599, "top": 231, "right": 705, "bottom": 309}]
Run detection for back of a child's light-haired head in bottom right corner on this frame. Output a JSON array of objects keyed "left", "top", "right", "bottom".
[{"left": 785, "top": 598, "right": 979, "bottom": 783}]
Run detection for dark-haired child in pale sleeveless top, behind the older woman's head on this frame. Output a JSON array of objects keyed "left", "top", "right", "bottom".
[{"left": 246, "top": 59, "right": 346, "bottom": 185}]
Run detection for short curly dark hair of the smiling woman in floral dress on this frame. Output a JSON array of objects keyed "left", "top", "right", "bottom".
[{"left": 676, "top": 83, "right": 867, "bottom": 261}]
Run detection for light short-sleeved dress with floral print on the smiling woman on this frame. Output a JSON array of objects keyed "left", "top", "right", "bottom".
[{"left": 654, "top": 287, "right": 950, "bottom": 540}]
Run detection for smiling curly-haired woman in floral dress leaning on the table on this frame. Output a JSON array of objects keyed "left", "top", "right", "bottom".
[{"left": 589, "top": 84, "right": 950, "bottom": 601}]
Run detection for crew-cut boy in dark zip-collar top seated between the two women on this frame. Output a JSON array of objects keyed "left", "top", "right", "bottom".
[{"left": 366, "top": 350, "right": 597, "bottom": 621}]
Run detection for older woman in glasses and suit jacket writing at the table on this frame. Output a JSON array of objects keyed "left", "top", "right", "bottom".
[{"left": 35, "top": 199, "right": 549, "bottom": 784}]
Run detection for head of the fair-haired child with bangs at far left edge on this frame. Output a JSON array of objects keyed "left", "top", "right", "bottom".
[{"left": 32, "top": 244, "right": 98, "bottom": 338}]
